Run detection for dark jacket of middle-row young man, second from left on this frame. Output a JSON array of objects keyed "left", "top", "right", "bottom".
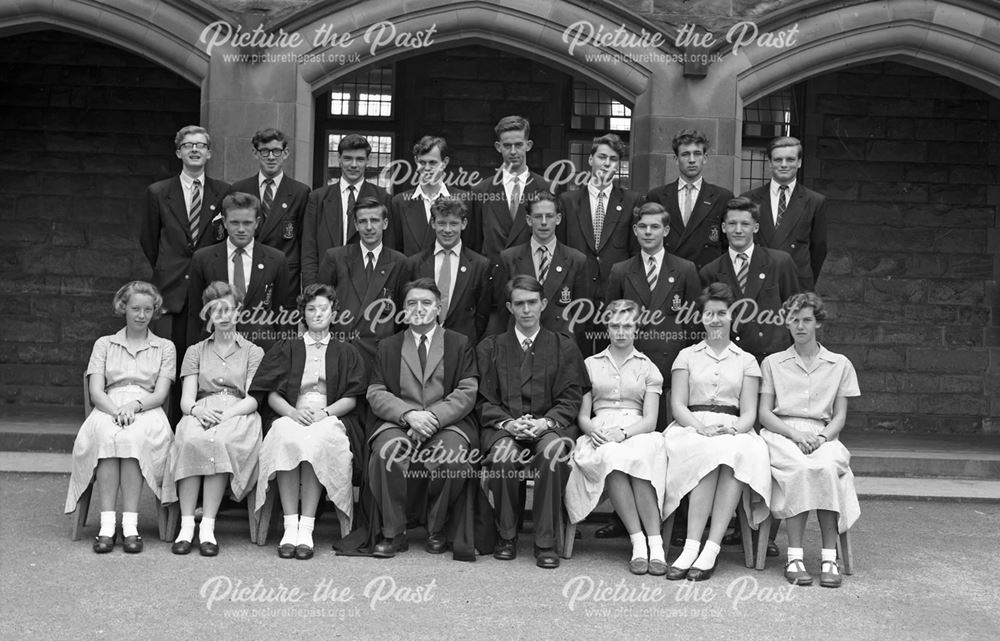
[{"left": 317, "top": 243, "right": 406, "bottom": 361}]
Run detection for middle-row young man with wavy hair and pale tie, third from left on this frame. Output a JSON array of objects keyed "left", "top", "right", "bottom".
[{"left": 406, "top": 198, "right": 492, "bottom": 345}]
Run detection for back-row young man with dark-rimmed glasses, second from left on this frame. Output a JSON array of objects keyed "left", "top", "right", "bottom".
[{"left": 229, "top": 129, "right": 309, "bottom": 294}]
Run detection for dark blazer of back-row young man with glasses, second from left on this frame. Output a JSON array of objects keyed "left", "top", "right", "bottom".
[{"left": 229, "top": 174, "right": 309, "bottom": 293}]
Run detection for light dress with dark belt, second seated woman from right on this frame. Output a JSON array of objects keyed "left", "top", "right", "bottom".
[{"left": 662, "top": 341, "right": 771, "bottom": 528}]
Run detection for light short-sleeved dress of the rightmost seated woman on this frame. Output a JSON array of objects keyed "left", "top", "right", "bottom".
[{"left": 760, "top": 346, "right": 861, "bottom": 532}]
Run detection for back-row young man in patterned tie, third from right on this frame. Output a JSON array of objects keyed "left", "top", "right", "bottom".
[{"left": 556, "top": 134, "right": 642, "bottom": 356}]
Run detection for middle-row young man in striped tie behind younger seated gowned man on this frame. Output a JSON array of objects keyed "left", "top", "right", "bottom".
[{"left": 496, "top": 191, "right": 591, "bottom": 336}]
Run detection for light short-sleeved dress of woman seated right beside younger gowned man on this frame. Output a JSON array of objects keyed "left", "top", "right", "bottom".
[{"left": 565, "top": 349, "right": 667, "bottom": 523}]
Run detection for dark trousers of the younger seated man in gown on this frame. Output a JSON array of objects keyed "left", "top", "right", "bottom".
[{"left": 486, "top": 432, "right": 572, "bottom": 548}]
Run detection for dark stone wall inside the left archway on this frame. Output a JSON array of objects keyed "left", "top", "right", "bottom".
[{"left": 0, "top": 31, "right": 200, "bottom": 404}]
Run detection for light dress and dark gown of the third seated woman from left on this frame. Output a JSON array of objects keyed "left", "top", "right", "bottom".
[{"left": 254, "top": 334, "right": 365, "bottom": 534}]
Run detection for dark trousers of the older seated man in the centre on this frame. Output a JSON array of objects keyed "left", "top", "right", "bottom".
[{"left": 368, "top": 427, "right": 472, "bottom": 539}]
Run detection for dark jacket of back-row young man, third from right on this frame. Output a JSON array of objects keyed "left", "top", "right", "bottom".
[{"left": 556, "top": 184, "right": 643, "bottom": 299}]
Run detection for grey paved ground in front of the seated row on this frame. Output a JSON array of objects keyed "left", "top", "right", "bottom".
[{"left": 0, "top": 473, "right": 1000, "bottom": 641}]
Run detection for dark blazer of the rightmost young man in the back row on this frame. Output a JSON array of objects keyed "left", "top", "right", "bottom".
[{"left": 743, "top": 181, "right": 826, "bottom": 292}]
